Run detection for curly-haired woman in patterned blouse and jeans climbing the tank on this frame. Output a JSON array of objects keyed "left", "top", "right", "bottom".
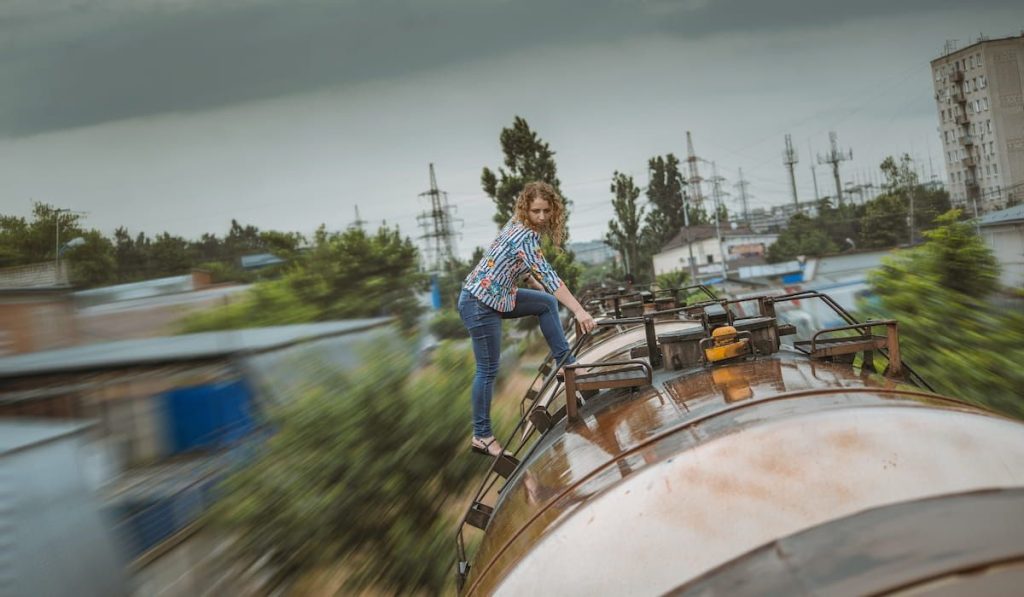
[{"left": 459, "top": 182, "right": 597, "bottom": 456}]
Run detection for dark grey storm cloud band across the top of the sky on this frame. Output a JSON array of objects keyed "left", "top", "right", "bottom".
[{"left": 0, "top": 0, "right": 1017, "bottom": 136}]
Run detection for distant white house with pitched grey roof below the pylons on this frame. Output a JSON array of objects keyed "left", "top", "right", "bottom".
[{"left": 653, "top": 225, "right": 778, "bottom": 279}]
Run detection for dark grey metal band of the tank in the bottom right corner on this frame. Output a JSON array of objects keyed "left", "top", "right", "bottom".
[{"left": 671, "top": 489, "right": 1024, "bottom": 597}]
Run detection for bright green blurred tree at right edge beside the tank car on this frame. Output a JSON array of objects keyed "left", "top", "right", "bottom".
[{"left": 860, "top": 210, "right": 1024, "bottom": 418}]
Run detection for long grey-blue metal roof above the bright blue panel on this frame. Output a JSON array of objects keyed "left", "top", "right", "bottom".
[{"left": 0, "top": 317, "right": 391, "bottom": 378}]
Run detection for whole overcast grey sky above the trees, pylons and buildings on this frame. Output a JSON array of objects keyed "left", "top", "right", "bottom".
[{"left": 0, "top": 0, "right": 1024, "bottom": 255}]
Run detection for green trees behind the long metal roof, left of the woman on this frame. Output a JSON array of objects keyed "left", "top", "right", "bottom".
[{"left": 182, "top": 226, "right": 425, "bottom": 332}]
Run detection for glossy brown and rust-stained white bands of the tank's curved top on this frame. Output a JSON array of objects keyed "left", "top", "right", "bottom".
[{"left": 467, "top": 352, "right": 1024, "bottom": 594}]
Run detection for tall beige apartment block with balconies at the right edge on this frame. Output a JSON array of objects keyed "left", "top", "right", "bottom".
[{"left": 931, "top": 32, "right": 1024, "bottom": 212}]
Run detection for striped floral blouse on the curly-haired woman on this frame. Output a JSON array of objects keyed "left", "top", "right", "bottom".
[{"left": 463, "top": 218, "right": 562, "bottom": 312}]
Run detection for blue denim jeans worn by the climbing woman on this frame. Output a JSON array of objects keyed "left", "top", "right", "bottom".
[{"left": 459, "top": 288, "right": 574, "bottom": 437}]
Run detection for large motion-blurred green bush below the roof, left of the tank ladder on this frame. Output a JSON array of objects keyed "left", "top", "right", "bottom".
[{"left": 209, "top": 343, "right": 484, "bottom": 595}]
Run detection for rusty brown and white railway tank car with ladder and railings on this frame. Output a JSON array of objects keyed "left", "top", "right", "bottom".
[{"left": 456, "top": 287, "right": 1024, "bottom": 595}]
